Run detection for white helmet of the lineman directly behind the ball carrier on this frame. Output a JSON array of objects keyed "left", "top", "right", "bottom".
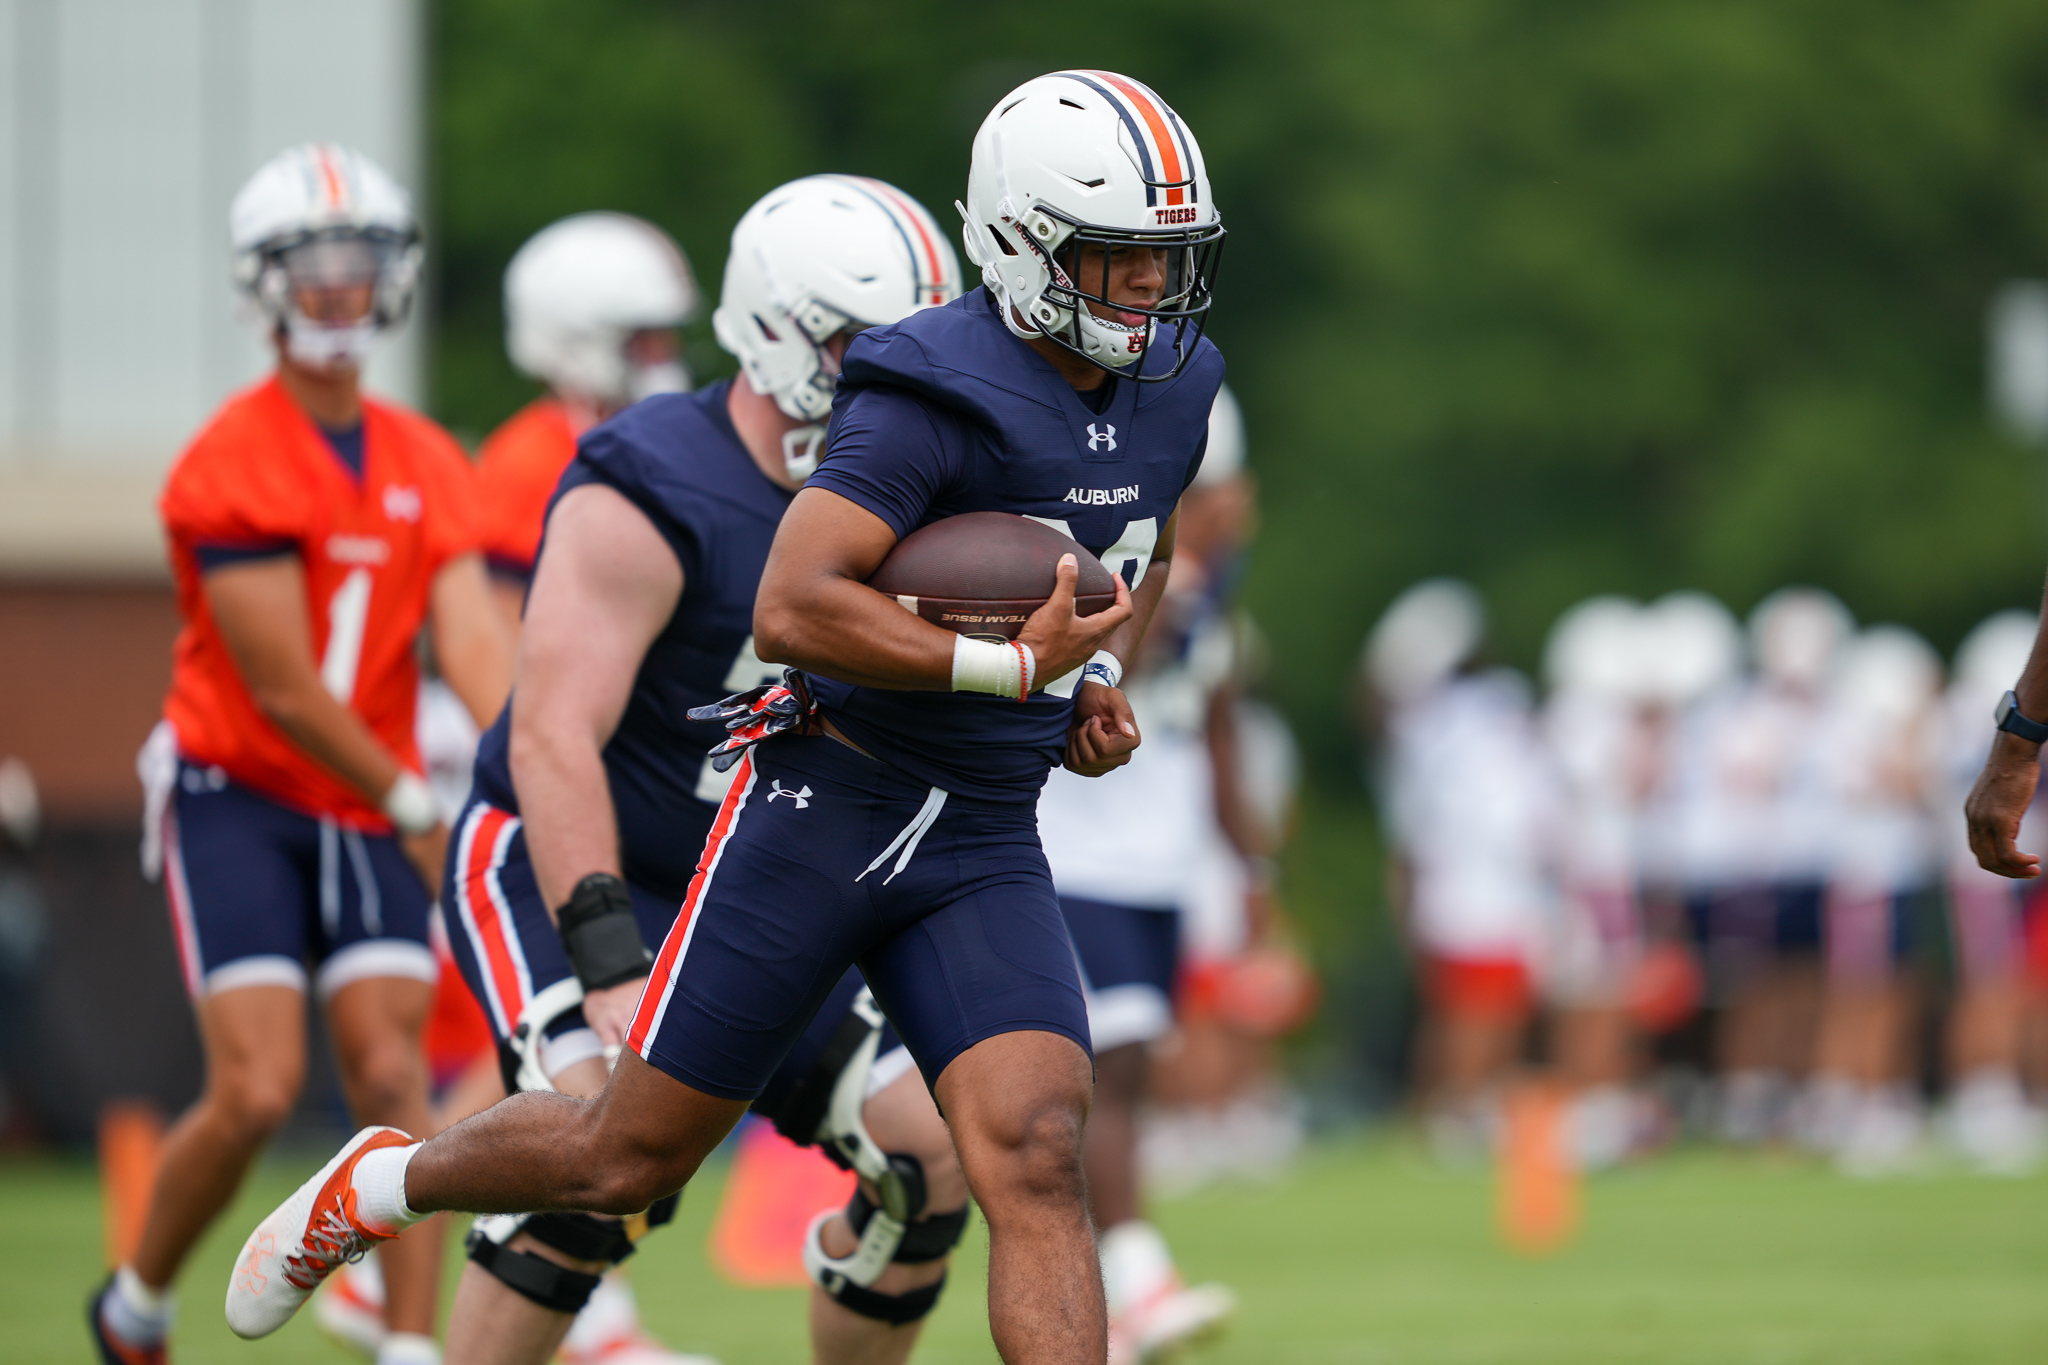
[{"left": 711, "top": 176, "right": 961, "bottom": 481}]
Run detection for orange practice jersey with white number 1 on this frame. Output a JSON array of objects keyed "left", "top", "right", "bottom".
[{"left": 158, "top": 377, "right": 479, "bottom": 831}]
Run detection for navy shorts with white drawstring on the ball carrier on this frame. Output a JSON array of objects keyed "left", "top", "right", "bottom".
[{"left": 627, "top": 737, "right": 1087, "bottom": 1099}]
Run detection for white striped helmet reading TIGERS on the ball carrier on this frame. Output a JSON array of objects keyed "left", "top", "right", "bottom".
[{"left": 956, "top": 72, "right": 1223, "bottom": 383}]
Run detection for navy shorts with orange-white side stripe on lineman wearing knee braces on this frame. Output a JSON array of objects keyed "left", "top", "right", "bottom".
[{"left": 440, "top": 796, "right": 905, "bottom": 1091}]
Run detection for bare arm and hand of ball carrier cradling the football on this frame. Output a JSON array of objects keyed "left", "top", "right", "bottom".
[{"left": 753, "top": 487, "right": 1138, "bottom": 692}]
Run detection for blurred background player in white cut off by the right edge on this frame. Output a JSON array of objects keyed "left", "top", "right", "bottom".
[{"left": 1937, "top": 612, "right": 2048, "bottom": 1173}]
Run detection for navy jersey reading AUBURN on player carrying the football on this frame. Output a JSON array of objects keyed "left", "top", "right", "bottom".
[{"left": 809, "top": 289, "right": 1223, "bottom": 800}]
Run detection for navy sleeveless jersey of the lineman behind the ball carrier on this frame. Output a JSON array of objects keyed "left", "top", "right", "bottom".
[{"left": 477, "top": 383, "right": 791, "bottom": 902}]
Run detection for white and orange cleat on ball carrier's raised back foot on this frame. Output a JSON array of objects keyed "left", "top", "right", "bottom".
[{"left": 227, "top": 1128, "right": 412, "bottom": 1340}]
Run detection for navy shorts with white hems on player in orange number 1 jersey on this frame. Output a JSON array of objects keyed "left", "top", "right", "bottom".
[{"left": 164, "top": 759, "right": 440, "bottom": 999}]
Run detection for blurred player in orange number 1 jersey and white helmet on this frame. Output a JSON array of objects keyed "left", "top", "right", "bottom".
[{"left": 90, "top": 143, "right": 510, "bottom": 1365}]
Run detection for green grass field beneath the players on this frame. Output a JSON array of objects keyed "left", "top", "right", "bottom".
[{"left": 16, "top": 1138, "right": 2048, "bottom": 1365}]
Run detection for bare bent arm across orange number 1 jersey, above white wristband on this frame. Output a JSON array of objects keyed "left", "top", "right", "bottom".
[{"left": 201, "top": 555, "right": 415, "bottom": 806}]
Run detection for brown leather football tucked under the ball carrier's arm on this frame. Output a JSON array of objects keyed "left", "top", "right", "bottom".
[{"left": 868, "top": 512, "right": 1116, "bottom": 641}]
